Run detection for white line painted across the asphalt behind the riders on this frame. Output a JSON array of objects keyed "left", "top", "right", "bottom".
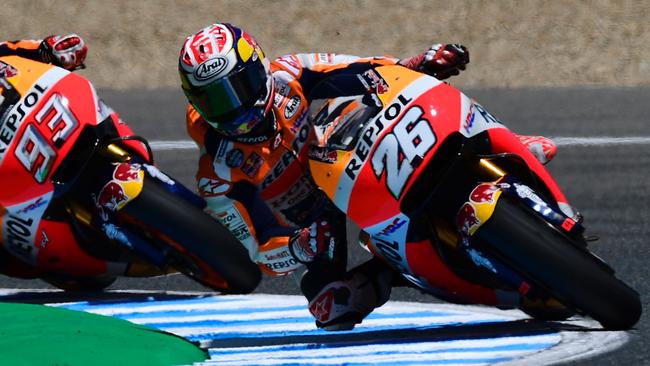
[{"left": 149, "top": 136, "right": 650, "bottom": 151}]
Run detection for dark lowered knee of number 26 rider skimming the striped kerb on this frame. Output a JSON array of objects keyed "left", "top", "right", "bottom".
[{"left": 309, "top": 260, "right": 394, "bottom": 331}]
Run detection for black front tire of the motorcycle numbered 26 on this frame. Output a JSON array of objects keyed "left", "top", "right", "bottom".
[{"left": 475, "top": 195, "right": 642, "bottom": 330}]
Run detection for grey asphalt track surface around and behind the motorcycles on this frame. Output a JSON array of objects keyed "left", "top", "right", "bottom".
[{"left": 0, "top": 88, "right": 650, "bottom": 365}]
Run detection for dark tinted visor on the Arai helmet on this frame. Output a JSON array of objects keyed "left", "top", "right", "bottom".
[{"left": 185, "top": 59, "right": 268, "bottom": 124}]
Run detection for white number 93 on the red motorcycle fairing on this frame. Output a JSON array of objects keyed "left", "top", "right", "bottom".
[{"left": 15, "top": 94, "right": 79, "bottom": 183}]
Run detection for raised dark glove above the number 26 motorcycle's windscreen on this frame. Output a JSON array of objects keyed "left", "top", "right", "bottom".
[{"left": 399, "top": 43, "right": 469, "bottom": 80}]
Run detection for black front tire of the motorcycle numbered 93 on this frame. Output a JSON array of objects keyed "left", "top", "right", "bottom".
[{"left": 121, "top": 176, "right": 262, "bottom": 294}]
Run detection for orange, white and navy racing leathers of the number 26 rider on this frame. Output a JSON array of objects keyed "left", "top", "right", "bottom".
[{"left": 182, "top": 53, "right": 398, "bottom": 276}]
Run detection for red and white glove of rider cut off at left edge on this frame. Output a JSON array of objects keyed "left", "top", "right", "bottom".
[{"left": 39, "top": 34, "right": 88, "bottom": 71}]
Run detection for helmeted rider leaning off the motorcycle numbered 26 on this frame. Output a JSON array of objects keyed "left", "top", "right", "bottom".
[{"left": 179, "top": 23, "right": 555, "bottom": 330}]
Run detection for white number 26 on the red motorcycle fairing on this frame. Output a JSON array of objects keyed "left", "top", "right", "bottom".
[{"left": 371, "top": 106, "right": 436, "bottom": 199}]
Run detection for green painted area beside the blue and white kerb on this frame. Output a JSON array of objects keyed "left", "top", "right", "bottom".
[{"left": 0, "top": 303, "right": 208, "bottom": 366}]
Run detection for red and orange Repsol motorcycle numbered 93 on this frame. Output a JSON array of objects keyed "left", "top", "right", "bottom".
[{"left": 0, "top": 56, "right": 261, "bottom": 293}]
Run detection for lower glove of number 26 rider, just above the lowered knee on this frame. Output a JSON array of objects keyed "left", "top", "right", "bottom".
[{"left": 289, "top": 219, "right": 336, "bottom": 264}]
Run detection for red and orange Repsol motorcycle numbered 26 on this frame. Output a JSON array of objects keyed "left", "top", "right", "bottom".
[{"left": 309, "top": 66, "right": 642, "bottom": 329}]
